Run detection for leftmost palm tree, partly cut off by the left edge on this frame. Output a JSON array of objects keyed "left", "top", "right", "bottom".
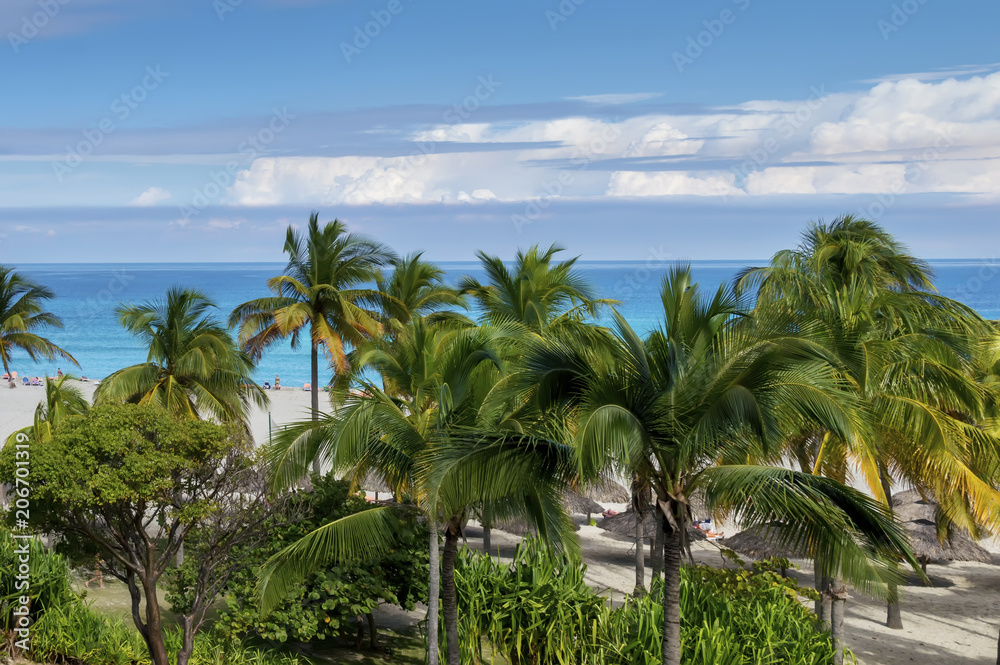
[{"left": 0, "top": 266, "right": 80, "bottom": 375}]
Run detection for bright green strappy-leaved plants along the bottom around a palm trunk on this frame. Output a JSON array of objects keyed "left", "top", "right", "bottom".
[{"left": 455, "top": 542, "right": 852, "bottom": 665}]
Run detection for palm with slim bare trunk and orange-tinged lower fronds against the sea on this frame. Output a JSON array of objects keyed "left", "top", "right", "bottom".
[{"left": 229, "top": 212, "right": 395, "bottom": 472}]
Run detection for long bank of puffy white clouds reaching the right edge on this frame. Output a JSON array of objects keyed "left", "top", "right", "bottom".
[{"left": 211, "top": 73, "right": 1000, "bottom": 205}]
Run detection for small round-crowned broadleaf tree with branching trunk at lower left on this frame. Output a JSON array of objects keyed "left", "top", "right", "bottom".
[{"left": 0, "top": 405, "right": 282, "bottom": 665}]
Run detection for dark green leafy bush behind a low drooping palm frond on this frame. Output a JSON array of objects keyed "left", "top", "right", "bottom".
[{"left": 215, "top": 476, "right": 429, "bottom": 642}]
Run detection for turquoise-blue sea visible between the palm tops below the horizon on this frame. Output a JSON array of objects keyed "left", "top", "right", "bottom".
[{"left": 12, "top": 259, "right": 1000, "bottom": 386}]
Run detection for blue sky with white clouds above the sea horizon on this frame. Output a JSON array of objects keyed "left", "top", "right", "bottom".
[{"left": 0, "top": 0, "right": 1000, "bottom": 262}]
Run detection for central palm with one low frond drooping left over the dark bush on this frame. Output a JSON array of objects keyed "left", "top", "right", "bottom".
[{"left": 261, "top": 318, "right": 572, "bottom": 665}]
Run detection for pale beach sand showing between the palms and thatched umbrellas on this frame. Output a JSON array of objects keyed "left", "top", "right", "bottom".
[{"left": 0, "top": 383, "right": 1000, "bottom": 665}]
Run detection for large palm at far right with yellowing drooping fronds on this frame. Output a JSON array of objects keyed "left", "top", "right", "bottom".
[{"left": 740, "top": 217, "right": 1000, "bottom": 628}]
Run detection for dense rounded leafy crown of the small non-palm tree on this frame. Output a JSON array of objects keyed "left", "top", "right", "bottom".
[{"left": 0, "top": 404, "right": 234, "bottom": 560}]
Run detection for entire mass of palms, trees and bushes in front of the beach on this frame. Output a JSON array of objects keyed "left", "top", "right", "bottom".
[{"left": 0, "top": 214, "right": 1000, "bottom": 665}]
